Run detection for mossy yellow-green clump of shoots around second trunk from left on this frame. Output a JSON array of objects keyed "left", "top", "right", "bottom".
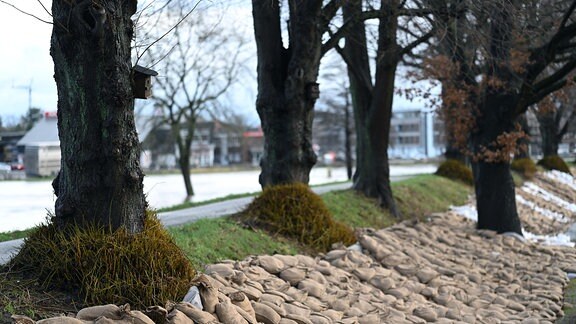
[{"left": 239, "top": 183, "right": 356, "bottom": 251}]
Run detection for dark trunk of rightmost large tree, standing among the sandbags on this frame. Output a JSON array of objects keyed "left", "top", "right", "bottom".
[{"left": 471, "top": 3, "right": 522, "bottom": 235}]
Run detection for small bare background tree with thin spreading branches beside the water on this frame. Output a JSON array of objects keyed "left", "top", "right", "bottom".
[{"left": 144, "top": 1, "right": 246, "bottom": 198}]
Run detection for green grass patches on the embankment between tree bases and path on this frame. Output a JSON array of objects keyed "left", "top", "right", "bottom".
[{"left": 0, "top": 175, "right": 471, "bottom": 267}]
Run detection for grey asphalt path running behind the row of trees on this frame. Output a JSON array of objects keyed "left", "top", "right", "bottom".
[{"left": 0, "top": 176, "right": 411, "bottom": 265}]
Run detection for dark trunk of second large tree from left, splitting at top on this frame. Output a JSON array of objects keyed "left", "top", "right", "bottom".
[{"left": 252, "top": 0, "right": 322, "bottom": 187}]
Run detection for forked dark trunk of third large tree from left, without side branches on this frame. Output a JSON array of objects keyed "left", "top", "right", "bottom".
[{"left": 343, "top": 1, "right": 400, "bottom": 217}]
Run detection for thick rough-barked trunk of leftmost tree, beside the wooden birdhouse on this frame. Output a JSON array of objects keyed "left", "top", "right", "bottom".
[{"left": 50, "top": 0, "right": 146, "bottom": 233}]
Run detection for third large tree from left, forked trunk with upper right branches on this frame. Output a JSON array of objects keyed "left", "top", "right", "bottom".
[{"left": 339, "top": 0, "right": 433, "bottom": 216}]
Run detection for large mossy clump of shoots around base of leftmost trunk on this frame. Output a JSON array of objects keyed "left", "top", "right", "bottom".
[{"left": 10, "top": 215, "right": 195, "bottom": 308}]
